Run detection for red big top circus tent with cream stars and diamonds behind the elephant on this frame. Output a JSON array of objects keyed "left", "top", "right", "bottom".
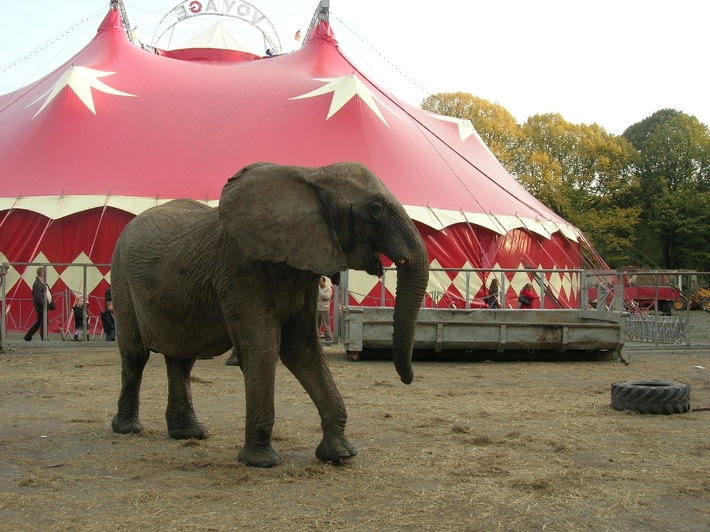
[{"left": 0, "top": 2, "right": 586, "bottom": 328}]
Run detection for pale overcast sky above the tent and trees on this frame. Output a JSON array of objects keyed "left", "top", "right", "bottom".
[{"left": 0, "top": 0, "right": 710, "bottom": 134}]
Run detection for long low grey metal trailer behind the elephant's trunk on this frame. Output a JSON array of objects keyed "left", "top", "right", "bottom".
[{"left": 341, "top": 307, "right": 626, "bottom": 360}]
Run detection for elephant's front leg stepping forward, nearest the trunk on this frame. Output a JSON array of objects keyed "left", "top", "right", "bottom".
[{"left": 281, "top": 316, "right": 357, "bottom": 462}]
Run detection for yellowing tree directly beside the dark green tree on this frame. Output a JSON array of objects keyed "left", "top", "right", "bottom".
[{"left": 516, "top": 114, "right": 640, "bottom": 267}]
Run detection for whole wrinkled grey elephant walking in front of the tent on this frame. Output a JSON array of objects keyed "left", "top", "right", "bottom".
[{"left": 111, "top": 163, "right": 428, "bottom": 467}]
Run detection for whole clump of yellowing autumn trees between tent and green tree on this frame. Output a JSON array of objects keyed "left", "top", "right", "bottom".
[{"left": 422, "top": 92, "right": 640, "bottom": 266}]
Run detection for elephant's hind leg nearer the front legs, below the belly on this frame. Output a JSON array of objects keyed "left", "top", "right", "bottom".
[{"left": 165, "top": 356, "right": 207, "bottom": 440}]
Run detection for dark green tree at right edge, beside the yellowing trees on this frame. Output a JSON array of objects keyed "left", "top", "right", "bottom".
[{"left": 623, "top": 109, "right": 710, "bottom": 271}]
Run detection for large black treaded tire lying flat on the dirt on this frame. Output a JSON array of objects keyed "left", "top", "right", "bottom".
[{"left": 611, "top": 381, "right": 690, "bottom": 415}]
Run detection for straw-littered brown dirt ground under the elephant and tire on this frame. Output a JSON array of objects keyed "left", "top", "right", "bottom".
[{"left": 0, "top": 342, "right": 710, "bottom": 531}]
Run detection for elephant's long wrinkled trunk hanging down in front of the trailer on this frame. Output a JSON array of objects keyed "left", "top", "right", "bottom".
[{"left": 390, "top": 224, "right": 429, "bottom": 384}]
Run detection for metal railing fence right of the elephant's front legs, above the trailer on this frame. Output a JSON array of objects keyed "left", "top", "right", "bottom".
[{"left": 344, "top": 268, "right": 710, "bottom": 345}]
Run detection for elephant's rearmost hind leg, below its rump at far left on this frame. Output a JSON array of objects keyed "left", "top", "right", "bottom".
[{"left": 111, "top": 348, "right": 150, "bottom": 434}]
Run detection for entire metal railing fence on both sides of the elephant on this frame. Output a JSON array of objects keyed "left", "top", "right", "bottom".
[{"left": 0, "top": 263, "right": 710, "bottom": 345}]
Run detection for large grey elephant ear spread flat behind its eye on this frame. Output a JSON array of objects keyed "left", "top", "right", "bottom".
[{"left": 219, "top": 163, "right": 347, "bottom": 275}]
